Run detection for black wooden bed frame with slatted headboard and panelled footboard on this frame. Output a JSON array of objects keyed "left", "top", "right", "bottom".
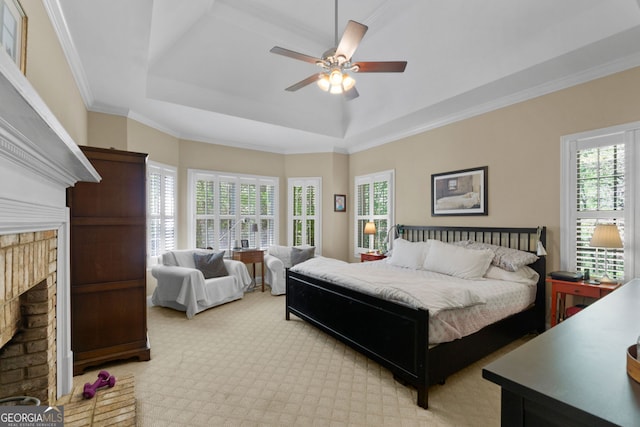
[{"left": 285, "top": 225, "right": 546, "bottom": 409}]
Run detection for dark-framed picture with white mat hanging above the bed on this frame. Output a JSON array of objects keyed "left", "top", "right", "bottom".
[{"left": 431, "top": 166, "right": 489, "bottom": 216}]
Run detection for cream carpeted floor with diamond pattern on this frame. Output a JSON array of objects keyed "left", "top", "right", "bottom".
[{"left": 74, "top": 291, "right": 526, "bottom": 426}]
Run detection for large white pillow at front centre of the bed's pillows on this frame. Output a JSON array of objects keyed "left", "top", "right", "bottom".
[{"left": 424, "top": 240, "right": 493, "bottom": 279}]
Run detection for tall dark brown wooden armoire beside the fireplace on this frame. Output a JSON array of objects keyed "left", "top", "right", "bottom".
[{"left": 67, "top": 147, "right": 151, "bottom": 375}]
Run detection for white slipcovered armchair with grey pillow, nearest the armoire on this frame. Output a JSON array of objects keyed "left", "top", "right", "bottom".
[{"left": 151, "top": 249, "right": 252, "bottom": 319}]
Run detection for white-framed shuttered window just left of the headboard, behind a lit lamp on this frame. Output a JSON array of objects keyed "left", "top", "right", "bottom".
[{"left": 354, "top": 171, "right": 394, "bottom": 255}]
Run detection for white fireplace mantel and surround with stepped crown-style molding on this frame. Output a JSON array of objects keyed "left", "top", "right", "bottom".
[{"left": 0, "top": 49, "right": 101, "bottom": 397}]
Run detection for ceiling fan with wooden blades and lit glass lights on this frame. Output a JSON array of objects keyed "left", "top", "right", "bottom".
[{"left": 270, "top": 0, "right": 407, "bottom": 101}]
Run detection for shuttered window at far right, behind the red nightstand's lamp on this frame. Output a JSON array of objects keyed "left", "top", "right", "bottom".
[{"left": 560, "top": 123, "right": 640, "bottom": 281}]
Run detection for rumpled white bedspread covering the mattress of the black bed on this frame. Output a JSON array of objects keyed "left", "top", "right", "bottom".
[{"left": 292, "top": 257, "right": 536, "bottom": 344}]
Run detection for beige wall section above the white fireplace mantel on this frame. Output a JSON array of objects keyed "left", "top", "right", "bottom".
[{"left": 20, "top": 0, "right": 87, "bottom": 145}]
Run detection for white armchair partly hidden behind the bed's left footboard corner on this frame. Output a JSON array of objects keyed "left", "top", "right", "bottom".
[{"left": 264, "top": 245, "right": 316, "bottom": 295}]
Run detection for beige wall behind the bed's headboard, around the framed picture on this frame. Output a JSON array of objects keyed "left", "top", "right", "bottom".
[{"left": 349, "top": 68, "right": 640, "bottom": 271}]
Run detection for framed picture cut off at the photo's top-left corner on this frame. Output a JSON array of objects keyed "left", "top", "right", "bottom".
[{"left": 0, "top": 0, "right": 27, "bottom": 74}]
